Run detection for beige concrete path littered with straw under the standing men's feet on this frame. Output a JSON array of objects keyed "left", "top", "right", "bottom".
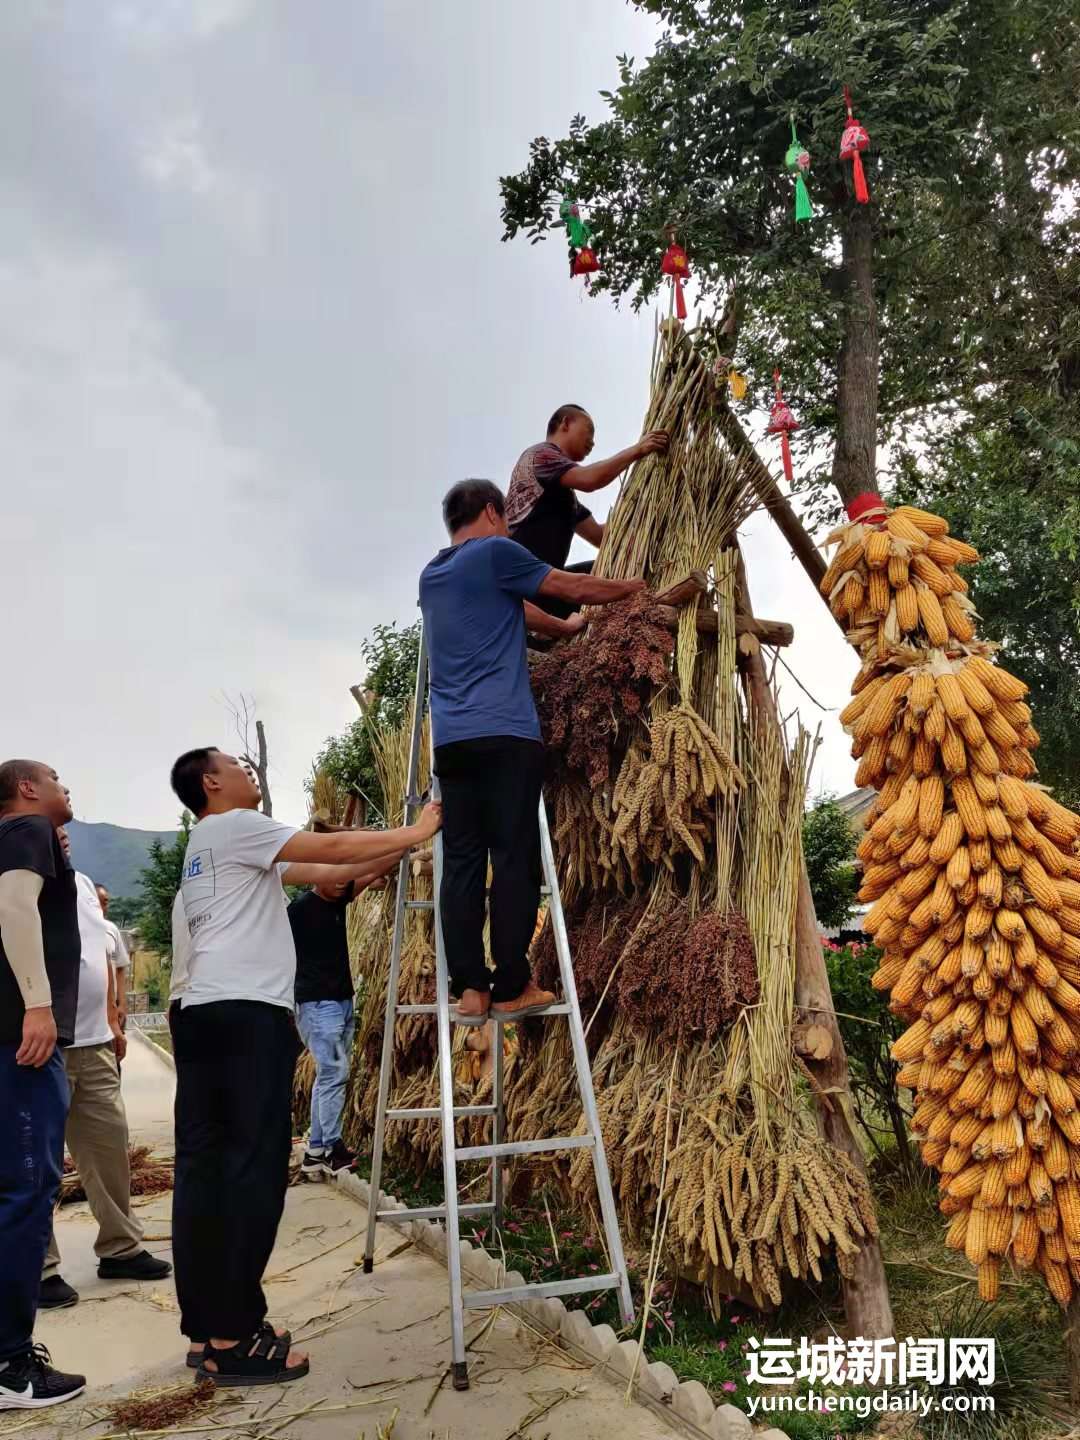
[{"left": 23, "top": 1045, "right": 685, "bottom": 1440}]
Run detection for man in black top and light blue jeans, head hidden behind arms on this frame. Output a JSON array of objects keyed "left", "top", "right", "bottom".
[{"left": 288, "top": 860, "right": 396, "bottom": 1175}]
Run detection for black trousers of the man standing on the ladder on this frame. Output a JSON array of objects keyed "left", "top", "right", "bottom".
[{"left": 435, "top": 736, "right": 544, "bottom": 1001}]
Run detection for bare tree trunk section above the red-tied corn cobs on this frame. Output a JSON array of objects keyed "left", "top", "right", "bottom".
[{"left": 832, "top": 204, "right": 878, "bottom": 504}]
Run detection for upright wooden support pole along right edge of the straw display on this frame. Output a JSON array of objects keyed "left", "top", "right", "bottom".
[{"left": 736, "top": 550, "right": 893, "bottom": 1339}]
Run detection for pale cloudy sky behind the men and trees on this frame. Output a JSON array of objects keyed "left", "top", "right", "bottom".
[{"left": 0, "top": 0, "right": 854, "bottom": 828}]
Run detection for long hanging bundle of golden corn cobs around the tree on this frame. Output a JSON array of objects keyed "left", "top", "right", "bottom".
[{"left": 822, "top": 497, "right": 1080, "bottom": 1305}]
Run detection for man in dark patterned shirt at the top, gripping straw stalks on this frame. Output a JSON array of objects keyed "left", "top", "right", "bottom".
[{"left": 507, "top": 405, "right": 668, "bottom": 619}]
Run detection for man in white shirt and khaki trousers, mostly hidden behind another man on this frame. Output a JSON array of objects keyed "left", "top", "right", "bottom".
[{"left": 37, "top": 827, "right": 171, "bottom": 1310}]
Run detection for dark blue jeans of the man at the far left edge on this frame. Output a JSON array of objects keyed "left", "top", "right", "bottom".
[{"left": 0, "top": 1045, "right": 68, "bottom": 1361}]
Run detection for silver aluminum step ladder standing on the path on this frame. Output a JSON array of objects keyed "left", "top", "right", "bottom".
[{"left": 364, "top": 632, "right": 634, "bottom": 1390}]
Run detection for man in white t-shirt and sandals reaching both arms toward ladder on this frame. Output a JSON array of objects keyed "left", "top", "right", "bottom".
[{"left": 168, "top": 746, "right": 442, "bottom": 1385}]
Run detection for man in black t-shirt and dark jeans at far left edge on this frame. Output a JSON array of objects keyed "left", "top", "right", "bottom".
[{"left": 0, "top": 760, "right": 86, "bottom": 1410}]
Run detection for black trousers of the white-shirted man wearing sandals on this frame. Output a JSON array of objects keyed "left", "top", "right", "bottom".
[{"left": 168, "top": 999, "right": 300, "bottom": 1341}]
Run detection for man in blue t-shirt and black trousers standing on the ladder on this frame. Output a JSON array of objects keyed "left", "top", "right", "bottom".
[{"left": 420, "top": 480, "right": 645, "bottom": 1024}]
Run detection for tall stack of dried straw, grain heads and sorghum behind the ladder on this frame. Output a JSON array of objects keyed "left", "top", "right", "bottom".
[{"left": 328, "top": 321, "right": 876, "bottom": 1306}]
